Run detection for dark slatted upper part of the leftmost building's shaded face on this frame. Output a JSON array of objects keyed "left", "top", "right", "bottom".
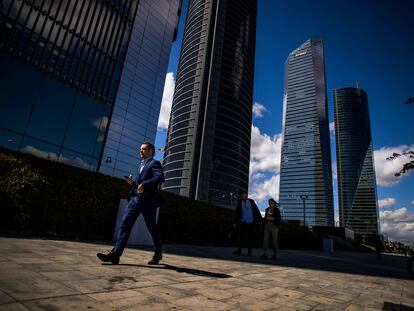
[{"left": 0, "top": 0, "right": 138, "bottom": 104}]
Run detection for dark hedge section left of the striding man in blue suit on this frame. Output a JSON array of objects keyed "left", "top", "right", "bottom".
[{"left": 0, "top": 150, "right": 128, "bottom": 239}]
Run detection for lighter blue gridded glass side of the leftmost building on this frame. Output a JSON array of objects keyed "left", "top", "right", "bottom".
[{"left": 100, "top": 0, "right": 181, "bottom": 177}]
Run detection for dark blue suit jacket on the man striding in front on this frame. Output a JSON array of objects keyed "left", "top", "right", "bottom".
[{"left": 132, "top": 158, "right": 164, "bottom": 208}]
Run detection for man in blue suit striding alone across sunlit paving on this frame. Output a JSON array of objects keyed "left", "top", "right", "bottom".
[{"left": 97, "top": 142, "right": 164, "bottom": 265}]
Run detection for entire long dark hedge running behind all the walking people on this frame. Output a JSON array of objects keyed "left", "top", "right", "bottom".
[{"left": 0, "top": 149, "right": 320, "bottom": 249}]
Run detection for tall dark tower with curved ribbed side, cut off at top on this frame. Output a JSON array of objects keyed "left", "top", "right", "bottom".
[{"left": 163, "top": 0, "right": 257, "bottom": 210}]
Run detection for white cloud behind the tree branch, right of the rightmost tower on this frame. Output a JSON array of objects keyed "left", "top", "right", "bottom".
[{"left": 374, "top": 145, "right": 414, "bottom": 187}]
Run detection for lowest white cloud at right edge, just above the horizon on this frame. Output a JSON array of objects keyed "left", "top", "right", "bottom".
[{"left": 380, "top": 207, "right": 414, "bottom": 243}]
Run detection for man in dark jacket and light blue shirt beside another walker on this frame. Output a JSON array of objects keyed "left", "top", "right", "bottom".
[{"left": 233, "top": 191, "right": 262, "bottom": 256}]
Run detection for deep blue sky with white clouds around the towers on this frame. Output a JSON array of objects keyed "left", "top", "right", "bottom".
[{"left": 156, "top": 0, "right": 414, "bottom": 242}]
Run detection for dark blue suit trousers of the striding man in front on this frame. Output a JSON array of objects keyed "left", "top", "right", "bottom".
[{"left": 112, "top": 196, "right": 162, "bottom": 256}]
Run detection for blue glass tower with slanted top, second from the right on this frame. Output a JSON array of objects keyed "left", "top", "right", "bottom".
[{"left": 279, "top": 39, "right": 334, "bottom": 226}]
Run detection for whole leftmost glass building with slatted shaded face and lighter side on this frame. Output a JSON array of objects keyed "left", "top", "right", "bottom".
[{"left": 0, "top": 0, "right": 179, "bottom": 176}]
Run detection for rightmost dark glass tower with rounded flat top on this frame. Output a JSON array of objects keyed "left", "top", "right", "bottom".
[{"left": 333, "top": 87, "right": 380, "bottom": 235}]
